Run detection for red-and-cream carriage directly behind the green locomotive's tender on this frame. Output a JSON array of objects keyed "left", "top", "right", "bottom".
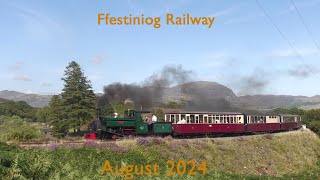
[{"left": 165, "top": 111, "right": 244, "bottom": 135}]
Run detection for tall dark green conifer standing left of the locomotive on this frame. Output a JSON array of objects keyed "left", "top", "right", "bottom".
[{"left": 61, "top": 61, "right": 96, "bottom": 132}]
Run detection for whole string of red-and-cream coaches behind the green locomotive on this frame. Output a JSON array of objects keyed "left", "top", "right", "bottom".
[{"left": 165, "top": 111, "right": 301, "bottom": 135}]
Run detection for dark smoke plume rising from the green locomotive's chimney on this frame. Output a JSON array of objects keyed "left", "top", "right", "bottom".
[{"left": 98, "top": 65, "right": 193, "bottom": 108}]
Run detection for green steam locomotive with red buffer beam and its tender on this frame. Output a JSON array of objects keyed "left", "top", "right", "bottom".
[{"left": 85, "top": 110, "right": 172, "bottom": 139}]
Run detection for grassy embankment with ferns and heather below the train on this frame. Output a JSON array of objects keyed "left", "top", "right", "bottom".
[{"left": 0, "top": 131, "right": 320, "bottom": 179}]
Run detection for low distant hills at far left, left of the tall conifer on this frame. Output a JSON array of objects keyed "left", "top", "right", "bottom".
[{"left": 0, "top": 90, "right": 52, "bottom": 107}]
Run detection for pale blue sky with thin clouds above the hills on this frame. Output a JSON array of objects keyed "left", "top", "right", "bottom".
[{"left": 0, "top": 0, "right": 320, "bottom": 96}]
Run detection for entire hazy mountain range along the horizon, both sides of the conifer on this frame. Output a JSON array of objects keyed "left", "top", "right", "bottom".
[{"left": 0, "top": 81, "right": 320, "bottom": 109}]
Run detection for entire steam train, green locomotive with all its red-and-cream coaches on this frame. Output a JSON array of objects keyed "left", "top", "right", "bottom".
[{"left": 85, "top": 110, "right": 301, "bottom": 140}]
